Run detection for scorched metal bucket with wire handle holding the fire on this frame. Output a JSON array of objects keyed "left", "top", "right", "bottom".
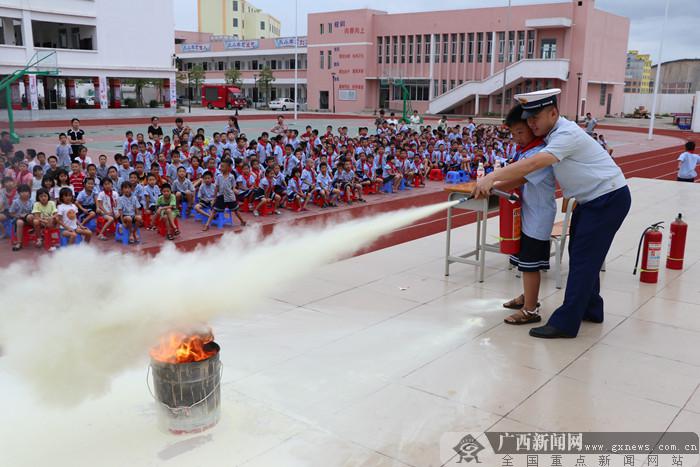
[{"left": 149, "top": 342, "right": 222, "bottom": 434}]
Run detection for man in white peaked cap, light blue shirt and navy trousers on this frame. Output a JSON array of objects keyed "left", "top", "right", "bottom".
[{"left": 475, "top": 89, "right": 631, "bottom": 338}]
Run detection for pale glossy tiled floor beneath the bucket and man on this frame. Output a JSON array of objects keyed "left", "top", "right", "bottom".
[{"left": 0, "top": 179, "right": 700, "bottom": 467}]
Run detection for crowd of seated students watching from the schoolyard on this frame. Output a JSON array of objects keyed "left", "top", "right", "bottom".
[{"left": 0, "top": 113, "right": 608, "bottom": 250}]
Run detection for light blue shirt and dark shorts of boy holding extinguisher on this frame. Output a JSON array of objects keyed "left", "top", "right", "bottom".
[{"left": 510, "top": 139, "right": 557, "bottom": 272}]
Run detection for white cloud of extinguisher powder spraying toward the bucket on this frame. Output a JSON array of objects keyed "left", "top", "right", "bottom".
[{"left": 0, "top": 203, "right": 450, "bottom": 405}]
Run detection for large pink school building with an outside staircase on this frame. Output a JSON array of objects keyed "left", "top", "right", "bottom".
[{"left": 307, "top": 0, "right": 629, "bottom": 117}]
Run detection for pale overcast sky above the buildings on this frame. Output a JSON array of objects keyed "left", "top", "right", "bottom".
[{"left": 173, "top": 0, "right": 700, "bottom": 62}]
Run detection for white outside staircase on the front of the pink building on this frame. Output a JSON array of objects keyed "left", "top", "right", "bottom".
[{"left": 428, "top": 59, "right": 569, "bottom": 114}]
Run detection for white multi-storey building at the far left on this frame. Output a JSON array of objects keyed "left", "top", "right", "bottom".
[{"left": 0, "top": 0, "right": 175, "bottom": 115}]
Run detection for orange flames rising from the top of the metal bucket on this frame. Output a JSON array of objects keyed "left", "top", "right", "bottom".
[{"left": 150, "top": 329, "right": 218, "bottom": 363}]
